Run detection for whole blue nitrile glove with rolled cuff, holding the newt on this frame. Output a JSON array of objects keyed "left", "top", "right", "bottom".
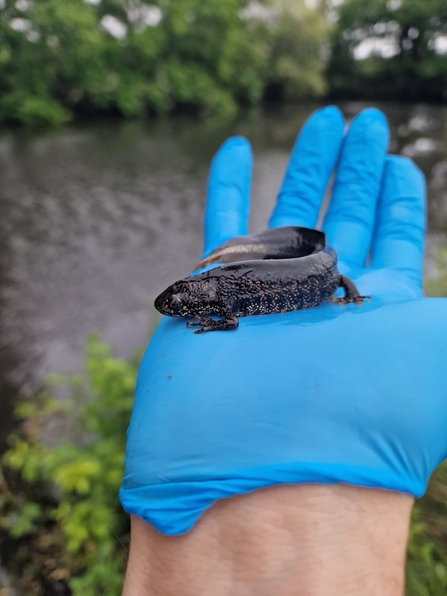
[{"left": 120, "top": 107, "right": 447, "bottom": 534}]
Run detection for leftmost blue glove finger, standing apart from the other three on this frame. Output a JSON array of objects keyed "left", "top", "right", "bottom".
[{"left": 203, "top": 137, "right": 253, "bottom": 256}]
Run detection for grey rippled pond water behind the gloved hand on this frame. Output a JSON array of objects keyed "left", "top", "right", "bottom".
[{"left": 0, "top": 103, "right": 447, "bottom": 438}]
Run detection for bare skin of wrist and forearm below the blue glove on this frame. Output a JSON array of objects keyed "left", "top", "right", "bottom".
[{"left": 124, "top": 485, "right": 413, "bottom": 596}]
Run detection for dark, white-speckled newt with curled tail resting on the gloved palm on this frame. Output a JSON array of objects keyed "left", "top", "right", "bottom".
[{"left": 155, "top": 226, "right": 369, "bottom": 333}]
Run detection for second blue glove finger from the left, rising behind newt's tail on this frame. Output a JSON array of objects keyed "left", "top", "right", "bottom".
[{"left": 269, "top": 106, "right": 345, "bottom": 228}]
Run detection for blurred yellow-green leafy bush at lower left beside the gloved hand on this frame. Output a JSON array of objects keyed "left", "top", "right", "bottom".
[{"left": 0, "top": 337, "right": 137, "bottom": 596}]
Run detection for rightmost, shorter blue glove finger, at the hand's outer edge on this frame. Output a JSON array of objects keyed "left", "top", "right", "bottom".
[{"left": 371, "top": 156, "right": 426, "bottom": 287}]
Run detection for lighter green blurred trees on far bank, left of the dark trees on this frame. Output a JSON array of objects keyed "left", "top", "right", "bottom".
[{"left": 0, "top": 0, "right": 326, "bottom": 126}]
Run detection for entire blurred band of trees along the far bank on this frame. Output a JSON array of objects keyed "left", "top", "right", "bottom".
[{"left": 0, "top": 0, "right": 447, "bottom": 126}]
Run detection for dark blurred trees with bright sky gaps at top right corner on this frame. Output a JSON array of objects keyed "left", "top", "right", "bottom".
[{"left": 327, "top": 0, "right": 447, "bottom": 101}]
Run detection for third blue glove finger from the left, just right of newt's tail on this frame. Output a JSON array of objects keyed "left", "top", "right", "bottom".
[{"left": 323, "top": 108, "right": 389, "bottom": 266}]
